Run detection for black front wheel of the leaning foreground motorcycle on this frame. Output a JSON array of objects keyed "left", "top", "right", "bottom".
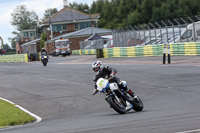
[{"left": 106, "top": 96, "right": 126, "bottom": 114}]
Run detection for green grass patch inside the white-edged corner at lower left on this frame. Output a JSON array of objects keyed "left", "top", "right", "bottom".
[{"left": 0, "top": 100, "right": 35, "bottom": 128}]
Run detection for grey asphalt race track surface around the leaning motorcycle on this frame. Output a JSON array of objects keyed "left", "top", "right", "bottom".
[{"left": 0, "top": 56, "right": 200, "bottom": 133}]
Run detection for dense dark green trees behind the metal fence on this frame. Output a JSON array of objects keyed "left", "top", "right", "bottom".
[{"left": 90, "top": 0, "right": 200, "bottom": 29}]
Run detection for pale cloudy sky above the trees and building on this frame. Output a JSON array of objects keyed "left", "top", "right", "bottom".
[{"left": 0, "top": 0, "right": 93, "bottom": 45}]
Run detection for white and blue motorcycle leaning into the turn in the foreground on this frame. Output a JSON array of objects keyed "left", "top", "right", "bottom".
[{"left": 96, "top": 78, "right": 144, "bottom": 114}]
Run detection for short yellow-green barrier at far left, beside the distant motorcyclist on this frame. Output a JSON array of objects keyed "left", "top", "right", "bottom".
[{"left": 0, "top": 54, "right": 28, "bottom": 63}]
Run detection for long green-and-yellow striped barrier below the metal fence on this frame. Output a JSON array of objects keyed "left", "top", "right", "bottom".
[{"left": 72, "top": 42, "right": 200, "bottom": 58}]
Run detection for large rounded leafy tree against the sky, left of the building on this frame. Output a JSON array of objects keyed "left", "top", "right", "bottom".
[{"left": 11, "top": 5, "right": 38, "bottom": 31}]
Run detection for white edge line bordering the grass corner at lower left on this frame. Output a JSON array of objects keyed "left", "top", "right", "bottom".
[{"left": 0, "top": 97, "right": 42, "bottom": 123}]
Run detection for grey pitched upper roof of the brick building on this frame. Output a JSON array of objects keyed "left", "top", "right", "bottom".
[{"left": 45, "top": 7, "right": 99, "bottom": 23}]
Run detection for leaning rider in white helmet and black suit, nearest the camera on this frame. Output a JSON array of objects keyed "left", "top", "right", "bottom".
[{"left": 92, "top": 61, "right": 135, "bottom": 97}]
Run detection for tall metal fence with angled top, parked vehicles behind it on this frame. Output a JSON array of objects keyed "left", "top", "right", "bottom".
[{"left": 113, "top": 16, "right": 200, "bottom": 47}]
